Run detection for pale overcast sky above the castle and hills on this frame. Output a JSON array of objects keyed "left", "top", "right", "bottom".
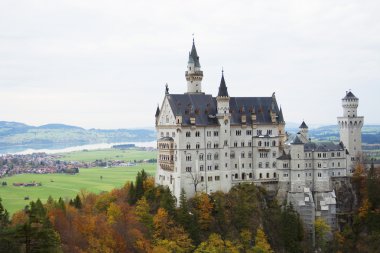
[{"left": 0, "top": 0, "right": 380, "bottom": 129}]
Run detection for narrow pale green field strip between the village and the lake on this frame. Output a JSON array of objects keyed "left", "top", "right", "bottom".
[{"left": 61, "top": 148, "right": 157, "bottom": 162}]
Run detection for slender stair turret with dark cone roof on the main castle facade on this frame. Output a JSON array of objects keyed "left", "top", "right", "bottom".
[{"left": 216, "top": 71, "right": 231, "bottom": 191}]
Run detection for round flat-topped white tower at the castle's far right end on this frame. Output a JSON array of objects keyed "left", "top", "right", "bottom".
[{"left": 338, "top": 91, "right": 364, "bottom": 161}]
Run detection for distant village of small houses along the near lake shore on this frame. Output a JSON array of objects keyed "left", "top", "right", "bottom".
[{"left": 0, "top": 146, "right": 157, "bottom": 178}]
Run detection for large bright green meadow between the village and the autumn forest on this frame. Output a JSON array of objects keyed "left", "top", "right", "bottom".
[{"left": 0, "top": 163, "right": 156, "bottom": 214}]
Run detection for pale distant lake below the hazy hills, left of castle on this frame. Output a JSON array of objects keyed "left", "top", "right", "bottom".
[{"left": 0, "top": 141, "right": 157, "bottom": 155}]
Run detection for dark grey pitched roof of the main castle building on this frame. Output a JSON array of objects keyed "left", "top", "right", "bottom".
[{"left": 167, "top": 93, "right": 280, "bottom": 125}]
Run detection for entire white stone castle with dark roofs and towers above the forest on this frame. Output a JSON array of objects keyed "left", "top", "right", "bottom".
[{"left": 155, "top": 41, "right": 363, "bottom": 235}]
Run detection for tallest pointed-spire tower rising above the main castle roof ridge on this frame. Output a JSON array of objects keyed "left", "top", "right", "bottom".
[{"left": 185, "top": 39, "right": 203, "bottom": 94}]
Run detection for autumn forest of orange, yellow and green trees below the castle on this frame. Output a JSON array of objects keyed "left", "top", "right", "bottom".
[{"left": 0, "top": 163, "right": 380, "bottom": 253}]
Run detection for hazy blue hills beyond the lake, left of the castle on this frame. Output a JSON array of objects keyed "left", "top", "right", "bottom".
[{"left": 0, "top": 121, "right": 156, "bottom": 153}]
